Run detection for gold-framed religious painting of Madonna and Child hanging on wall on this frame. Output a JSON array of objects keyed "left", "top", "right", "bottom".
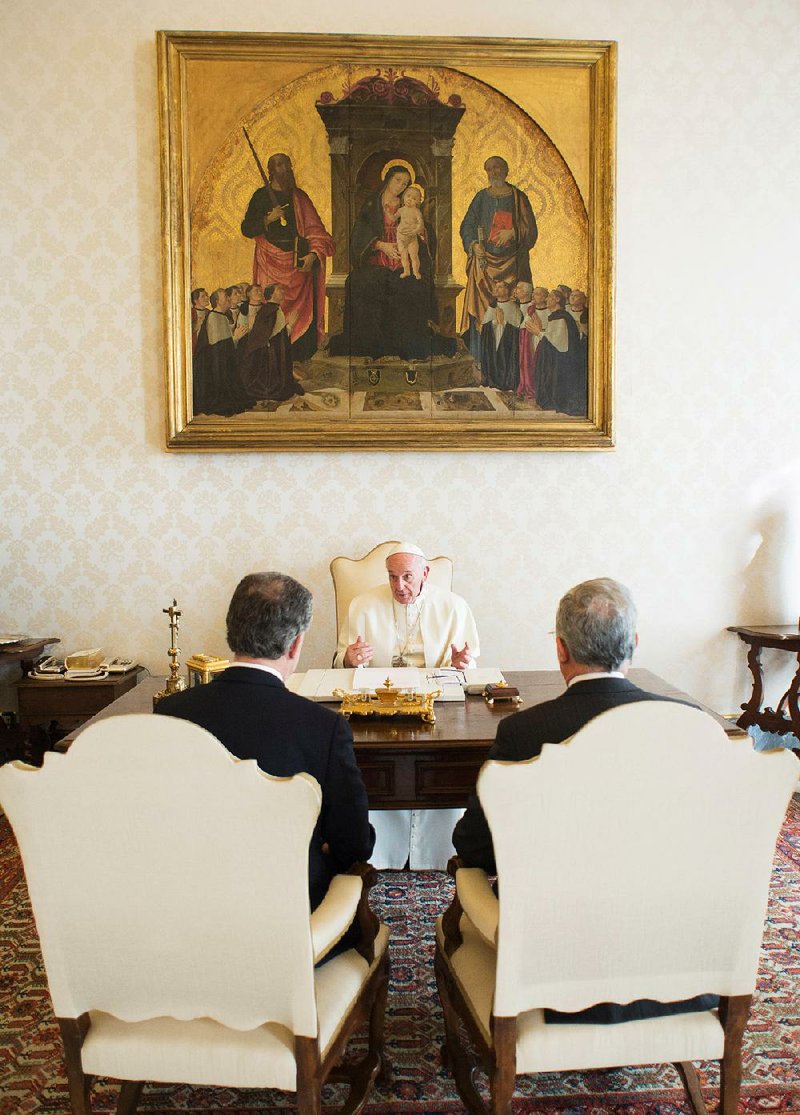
[{"left": 157, "top": 31, "right": 616, "bottom": 452}]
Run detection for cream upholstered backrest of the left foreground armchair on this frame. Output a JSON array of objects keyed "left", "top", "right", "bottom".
[{"left": 0, "top": 716, "right": 320, "bottom": 1034}]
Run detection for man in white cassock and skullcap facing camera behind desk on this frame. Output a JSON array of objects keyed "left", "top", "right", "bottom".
[{"left": 334, "top": 542, "right": 480, "bottom": 870}]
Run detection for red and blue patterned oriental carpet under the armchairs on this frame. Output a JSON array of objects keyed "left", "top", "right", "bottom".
[{"left": 0, "top": 796, "right": 800, "bottom": 1115}]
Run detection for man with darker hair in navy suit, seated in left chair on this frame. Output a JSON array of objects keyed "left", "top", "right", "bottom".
[{"left": 156, "top": 573, "right": 375, "bottom": 957}]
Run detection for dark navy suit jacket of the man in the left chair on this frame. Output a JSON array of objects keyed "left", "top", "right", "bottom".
[{"left": 156, "top": 666, "right": 375, "bottom": 909}]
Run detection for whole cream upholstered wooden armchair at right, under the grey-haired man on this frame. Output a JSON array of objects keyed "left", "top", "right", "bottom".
[{"left": 435, "top": 701, "right": 797, "bottom": 1115}]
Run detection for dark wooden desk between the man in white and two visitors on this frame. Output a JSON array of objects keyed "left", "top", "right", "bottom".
[{"left": 59, "top": 669, "right": 744, "bottom": 809}]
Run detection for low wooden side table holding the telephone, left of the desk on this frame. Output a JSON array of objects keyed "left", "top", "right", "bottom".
[{"left": 15, "top": 666, "right": 145, "bottom": 746}]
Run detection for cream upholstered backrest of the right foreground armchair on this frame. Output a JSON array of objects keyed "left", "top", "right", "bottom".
[{"left": 478, "top": 701, "right": 798, "bottom": 1021}]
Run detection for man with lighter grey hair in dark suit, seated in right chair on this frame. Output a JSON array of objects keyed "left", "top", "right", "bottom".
[{"left": 453, "top": 578, "right": 719, "bottom": 1022}]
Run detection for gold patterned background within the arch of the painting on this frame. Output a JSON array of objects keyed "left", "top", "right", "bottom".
[{"left": 191, "top": 65, "right": 588, "bottom": 309}]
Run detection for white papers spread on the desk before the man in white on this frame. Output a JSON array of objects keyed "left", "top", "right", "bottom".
[{"left": 288, "top": 666, "right": 503, "bottom": 702}]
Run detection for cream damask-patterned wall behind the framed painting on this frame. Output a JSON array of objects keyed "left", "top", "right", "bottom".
[{"left": 0, "top": 0, "right": 800, "bottom": 711}]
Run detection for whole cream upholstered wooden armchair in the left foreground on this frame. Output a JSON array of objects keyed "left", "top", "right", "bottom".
[{"left": 0, "top": 715, "right": 388, "bottom": 1115}]
